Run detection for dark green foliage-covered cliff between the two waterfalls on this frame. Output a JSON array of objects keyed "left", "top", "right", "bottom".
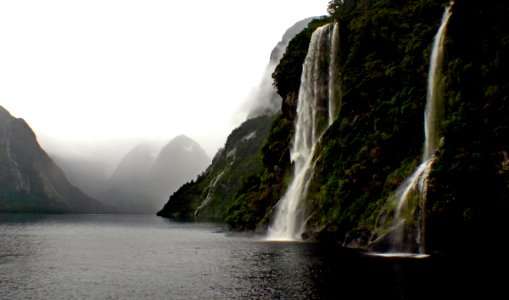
[{"left": 302, "top": 0, "right": 443, "bottom": 242}]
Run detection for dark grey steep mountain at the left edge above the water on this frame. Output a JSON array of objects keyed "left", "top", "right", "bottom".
[{"left": 0, "top": 106, "right": 109, "bottom": 213}]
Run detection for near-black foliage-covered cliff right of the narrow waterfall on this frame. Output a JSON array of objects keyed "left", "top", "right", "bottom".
[{"left": 426, "top": 1, "right": 509, "bottom": 251}]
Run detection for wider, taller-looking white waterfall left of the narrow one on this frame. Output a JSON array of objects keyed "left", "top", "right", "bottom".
[{"left": 267, "top": 23, "right": 341, "bottom": 241}]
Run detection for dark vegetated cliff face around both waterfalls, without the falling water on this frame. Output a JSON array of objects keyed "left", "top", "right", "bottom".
[{"left": 226, "top": 0, "right": 509, "bottom": 252}]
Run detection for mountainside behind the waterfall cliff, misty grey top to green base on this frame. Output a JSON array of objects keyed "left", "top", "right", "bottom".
[{"left": 158, "top": 18, "right": 312, "bottom": 222}]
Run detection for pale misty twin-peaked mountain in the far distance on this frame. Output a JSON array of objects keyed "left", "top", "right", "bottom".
[{"left": 100, "top": 135, "right": 210, "bottom": 213}]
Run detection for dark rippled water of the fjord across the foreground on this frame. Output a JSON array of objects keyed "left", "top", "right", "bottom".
[{"left": 0, "top": 215, "right": 507, "bottom": 299}]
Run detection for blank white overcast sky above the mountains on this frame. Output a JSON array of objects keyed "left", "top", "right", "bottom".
[{"left": 0, "top": 0, "right": 328, "bottom": 156}]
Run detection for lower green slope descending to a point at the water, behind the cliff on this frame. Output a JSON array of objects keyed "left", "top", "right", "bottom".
[{"left": 158, "top": 116, "right": 273, "bottom": 220}]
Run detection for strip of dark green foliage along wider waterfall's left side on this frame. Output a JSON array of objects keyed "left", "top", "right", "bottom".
[{"left": 225, "top": 17, "right": 340, "bottom": 230}]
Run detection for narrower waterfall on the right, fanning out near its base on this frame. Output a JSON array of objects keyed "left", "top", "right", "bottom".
[{"left": 391, "top": 3, "right": 452, "bottom": 253}]
